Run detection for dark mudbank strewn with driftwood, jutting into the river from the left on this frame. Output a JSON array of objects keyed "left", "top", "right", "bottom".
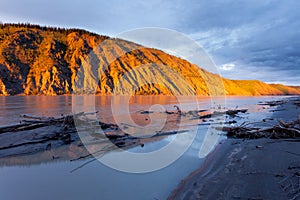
[{"left": 0, "top": 112, "right": 192, "bottom": 158}]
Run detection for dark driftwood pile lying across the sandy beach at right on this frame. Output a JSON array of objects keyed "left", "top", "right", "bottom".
[{"left": 216, "top": 119, "right": 300, "bottom": 139}]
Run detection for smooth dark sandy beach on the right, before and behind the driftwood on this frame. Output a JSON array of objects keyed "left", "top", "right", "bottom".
[{"left": 169, "top": 96, "right": 300, "bottom": 200}]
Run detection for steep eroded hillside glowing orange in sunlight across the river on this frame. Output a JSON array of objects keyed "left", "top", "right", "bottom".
[{"left": 0, "top": 24, "right": 300, "bottom": 95}]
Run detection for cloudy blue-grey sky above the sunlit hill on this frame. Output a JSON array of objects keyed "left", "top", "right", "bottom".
[{"left": 0, "top": 0, "right": 300, "bottom": 85}]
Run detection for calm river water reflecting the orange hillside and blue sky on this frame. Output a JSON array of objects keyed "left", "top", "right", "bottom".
[{"left": 0, "top": 96, "right": 284, "bottom": 200}]
